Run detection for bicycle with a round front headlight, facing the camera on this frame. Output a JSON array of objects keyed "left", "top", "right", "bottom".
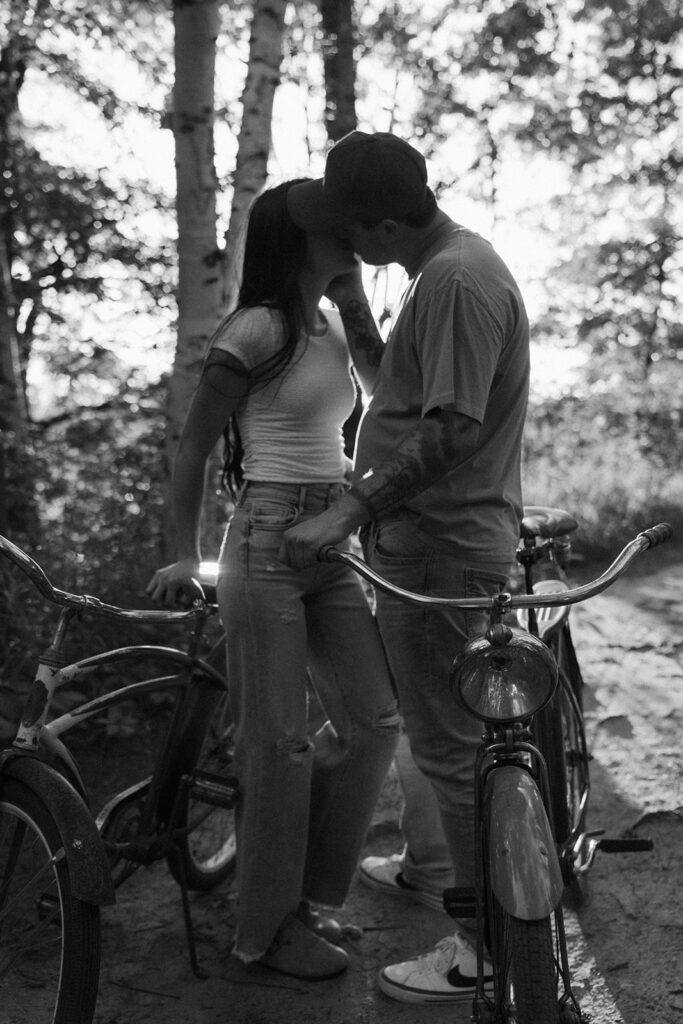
[{"left": 318, "top": 516, "right": 671, "bottom": 1024}]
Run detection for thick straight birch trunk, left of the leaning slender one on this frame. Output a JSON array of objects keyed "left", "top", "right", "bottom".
[{"left": 165, "top": 0, "right": 220, "bottom": 545}]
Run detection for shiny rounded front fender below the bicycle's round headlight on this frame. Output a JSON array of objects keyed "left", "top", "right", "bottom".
[{"left": 483, "top": 765, "right": 563, "bottom": 921}]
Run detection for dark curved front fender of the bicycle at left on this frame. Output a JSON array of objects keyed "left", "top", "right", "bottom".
[{"left": 0, "top": 750, "right": 116, "bottom": 906}]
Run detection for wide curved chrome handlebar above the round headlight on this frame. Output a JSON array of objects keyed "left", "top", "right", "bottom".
[{"left": 317, "top": 522, "right": 673, "bottom": 609}]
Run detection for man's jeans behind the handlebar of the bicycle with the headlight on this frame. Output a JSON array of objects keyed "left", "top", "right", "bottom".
[{"left": 364, "top": 519, "right": 510, "bottom": 888}]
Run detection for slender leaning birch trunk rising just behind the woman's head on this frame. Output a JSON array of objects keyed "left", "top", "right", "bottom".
[{"left": 221, "top": 0, "right": 287, "bottom": 313}]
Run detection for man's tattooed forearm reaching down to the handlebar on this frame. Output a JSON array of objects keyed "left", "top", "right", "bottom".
[{"left": 351, "top": 410, "right": 479, "bottom": 517}]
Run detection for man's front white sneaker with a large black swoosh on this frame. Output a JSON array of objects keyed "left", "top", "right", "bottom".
[{"left": 379, "top": 933, "right": 494, "bottom": 1002}]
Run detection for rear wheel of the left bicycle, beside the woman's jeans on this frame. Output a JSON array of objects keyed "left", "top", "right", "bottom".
[{"left": 168, "top": 693, "right": 237, "bottom": 892}]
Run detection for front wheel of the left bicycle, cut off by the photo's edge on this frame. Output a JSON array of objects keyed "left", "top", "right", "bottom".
[{"left": 0, "top": 779, "right": 99, "bottom": 1024}]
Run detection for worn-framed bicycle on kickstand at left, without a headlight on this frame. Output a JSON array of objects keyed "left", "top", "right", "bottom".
[{"left": 0, "top": 537, "right": 238, "bottom": 1024}]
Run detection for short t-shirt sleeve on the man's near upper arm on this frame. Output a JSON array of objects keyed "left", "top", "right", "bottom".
[{"left": 416, "top": 281, "right": 502, "bottom": 423}]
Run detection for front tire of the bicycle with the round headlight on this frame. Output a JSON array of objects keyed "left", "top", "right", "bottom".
[{"left": 489, "top": 896, "right": 560, "bottom": 1024}]
